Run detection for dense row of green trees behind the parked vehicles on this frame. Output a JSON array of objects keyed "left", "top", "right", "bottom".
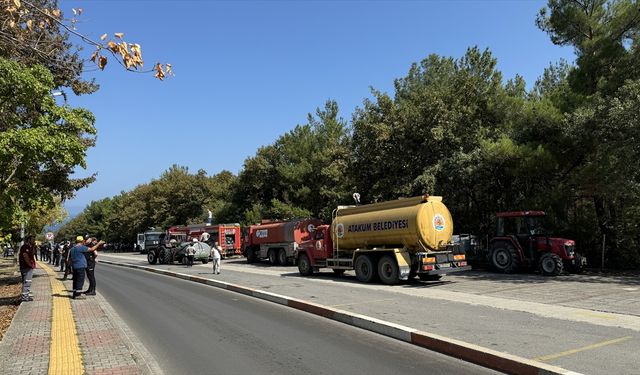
[{"left": 59, "top": 0, "right": 640, "bottom": 268}]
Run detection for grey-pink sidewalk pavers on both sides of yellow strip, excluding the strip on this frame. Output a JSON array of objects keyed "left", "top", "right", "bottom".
[{"left": 0, "top": 267, "right": 162, "bottom": 375}]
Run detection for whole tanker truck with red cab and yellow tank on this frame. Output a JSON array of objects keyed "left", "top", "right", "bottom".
[{"left": 296, "top": 195, "right": 471, "bottom": 284}]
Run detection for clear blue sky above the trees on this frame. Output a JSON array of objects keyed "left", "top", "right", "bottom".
[{"left": 60, "top": 0, "right": 574, "bottom": 213}]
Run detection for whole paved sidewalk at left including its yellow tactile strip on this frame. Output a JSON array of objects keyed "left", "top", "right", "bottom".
[{"left": 0, "top": 262, "right": 162, "bottom": 375}]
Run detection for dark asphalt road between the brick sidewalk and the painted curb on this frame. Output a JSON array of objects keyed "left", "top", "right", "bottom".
[{"left": 96, "top": 264, "right": 494, "bottom": 375}]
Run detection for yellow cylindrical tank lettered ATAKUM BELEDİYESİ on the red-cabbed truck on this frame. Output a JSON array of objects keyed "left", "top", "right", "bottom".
[{"left": 332, "top": 195, "right": 453, "bottom": 253}]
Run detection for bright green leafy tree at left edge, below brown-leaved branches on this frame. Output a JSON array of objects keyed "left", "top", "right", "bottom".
[{"left": 0, "top": 59, "right": 96, "bottom": 236}]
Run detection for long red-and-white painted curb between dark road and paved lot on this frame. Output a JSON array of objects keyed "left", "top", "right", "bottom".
[{"left": 100, "top": 260, "right": 581, "bottom": 375}]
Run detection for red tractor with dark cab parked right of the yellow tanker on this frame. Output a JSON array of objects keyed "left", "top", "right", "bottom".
[{"left": 489, "top": 211, "right": 586, "bottom": 276}]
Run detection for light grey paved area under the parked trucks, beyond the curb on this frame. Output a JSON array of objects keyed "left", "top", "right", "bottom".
[{"left": 100, "top": 254, "right": 640, "bottom": 375}]
